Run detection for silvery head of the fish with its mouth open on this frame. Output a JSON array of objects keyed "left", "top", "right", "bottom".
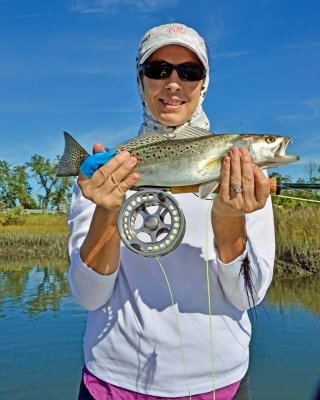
[{"left": 242, "top": 135, "right": 299, "bottom": 168}]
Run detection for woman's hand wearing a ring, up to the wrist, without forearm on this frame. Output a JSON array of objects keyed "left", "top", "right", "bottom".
[{"left": 213, "top": 147, "right": 270, "bottom": 217}]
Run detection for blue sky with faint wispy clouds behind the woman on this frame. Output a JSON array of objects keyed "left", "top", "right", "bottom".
[{"left": 0, "top": 0, "right": 320, "bottom": 177}]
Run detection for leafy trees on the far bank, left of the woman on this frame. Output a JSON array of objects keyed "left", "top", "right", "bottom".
[{"left": 0, "top": 154, "right": 74, "bottom": 211}]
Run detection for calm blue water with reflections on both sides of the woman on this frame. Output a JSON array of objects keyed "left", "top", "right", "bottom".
[{"left": 0, "top": 262, "right": 320, "bottom": 400}]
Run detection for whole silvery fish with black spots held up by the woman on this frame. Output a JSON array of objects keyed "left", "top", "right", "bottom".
[{"left": 57, "top": 127, "right": 299, "bottom": 198}]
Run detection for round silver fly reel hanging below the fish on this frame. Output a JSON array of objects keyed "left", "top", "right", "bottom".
[{"left": 118, "top": 189, "right": 186, "bottom": 257}]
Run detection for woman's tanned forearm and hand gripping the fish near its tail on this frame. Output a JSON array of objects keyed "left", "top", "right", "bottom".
[{"left": 78, "top": 144, "right": 139, "bottom": 275}]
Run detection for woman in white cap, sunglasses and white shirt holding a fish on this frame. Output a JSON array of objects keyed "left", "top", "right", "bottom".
[{"left": 69, "top": 24, "right": 274, "bottom": 400}]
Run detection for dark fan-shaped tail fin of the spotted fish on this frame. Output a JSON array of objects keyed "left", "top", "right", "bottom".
[{"left": 57, "top": 132, "right": 89, "bottom": 176}]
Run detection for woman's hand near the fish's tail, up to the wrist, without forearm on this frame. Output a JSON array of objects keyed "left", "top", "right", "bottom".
[{"left": 78, "top": 144, "right": 139, "bottom": 210}]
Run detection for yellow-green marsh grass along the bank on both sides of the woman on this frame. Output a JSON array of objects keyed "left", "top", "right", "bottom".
[{"left": 0, "top": 204, "right": 320, "bottom": 277}]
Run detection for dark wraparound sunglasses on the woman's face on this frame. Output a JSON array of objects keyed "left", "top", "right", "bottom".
[{"left": 139, "top": 61, "right": 207, "bottom": 82}]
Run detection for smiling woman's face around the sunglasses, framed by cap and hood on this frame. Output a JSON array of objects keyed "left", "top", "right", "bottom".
[{"left": 142, "top": 45, "right": 203, "bottom": 126}]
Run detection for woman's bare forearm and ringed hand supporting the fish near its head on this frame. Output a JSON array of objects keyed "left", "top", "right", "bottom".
[{"left": 212, "top": 148, "right": 270, "bottom": 264}]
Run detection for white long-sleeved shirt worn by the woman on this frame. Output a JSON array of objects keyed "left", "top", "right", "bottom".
[{"left": 69, "top": 186, "right": 275, "bottom": 397}]
